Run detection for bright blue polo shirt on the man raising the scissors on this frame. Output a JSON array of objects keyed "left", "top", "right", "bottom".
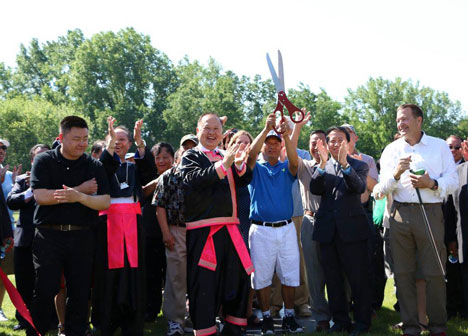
[{"left": 249, "top": 160, "right": 296, "bottom": 222}]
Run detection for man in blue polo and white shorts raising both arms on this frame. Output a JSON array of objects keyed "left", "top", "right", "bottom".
[{"left": 248, "top": 114, "right": 302, "bottom": 335}]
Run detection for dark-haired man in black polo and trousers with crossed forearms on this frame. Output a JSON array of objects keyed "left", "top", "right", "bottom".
[{"left": 27, "top": 116, "right": 110, "bottom": 336}]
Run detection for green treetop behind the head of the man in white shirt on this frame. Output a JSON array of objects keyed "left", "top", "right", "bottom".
[{"left": 343, "top": 77, "right": 466, "bottom": 158}]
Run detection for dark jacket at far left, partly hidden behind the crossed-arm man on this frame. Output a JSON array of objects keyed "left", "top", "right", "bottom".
[{"left": 7, "top": 174, "right": 36, "bottom": 247}]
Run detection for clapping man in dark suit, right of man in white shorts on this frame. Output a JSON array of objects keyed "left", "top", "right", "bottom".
[{"left": 310, "top": 127, "right": 371, "bottom": 336}]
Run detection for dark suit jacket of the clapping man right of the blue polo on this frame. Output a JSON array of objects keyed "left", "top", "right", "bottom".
[{"left": 310, "top": 156, "right": 371, "bottom": 243}]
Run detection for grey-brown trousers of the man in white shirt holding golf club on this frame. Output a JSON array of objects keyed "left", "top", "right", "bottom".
[{"left": 390, "top": 202, "right": 447, "bottom": 335}]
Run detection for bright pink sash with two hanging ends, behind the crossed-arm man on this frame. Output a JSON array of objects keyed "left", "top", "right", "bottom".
[{"left": 99, "top": 203, "right": 141, "bottom": 269}]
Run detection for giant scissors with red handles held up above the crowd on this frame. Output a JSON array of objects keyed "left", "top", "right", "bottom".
[{"left": 267, "top": 50, "right": 304, "bottom": 134}]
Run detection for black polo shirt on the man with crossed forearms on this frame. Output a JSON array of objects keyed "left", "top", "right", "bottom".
[{"left": 31, "top": 146, "right": 109, "bottom": 226}]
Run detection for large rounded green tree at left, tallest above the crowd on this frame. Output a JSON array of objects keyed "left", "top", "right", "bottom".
[{"left": 70, "top": 28, "right": 177, "bottom": 142}]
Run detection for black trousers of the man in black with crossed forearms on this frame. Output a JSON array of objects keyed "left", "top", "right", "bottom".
[{"left": 27, "top": 228, "right": 94, "bottom": 336}]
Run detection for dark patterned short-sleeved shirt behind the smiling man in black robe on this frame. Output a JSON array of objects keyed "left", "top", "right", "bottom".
[{"left": 152, "top": 167, "right": 185, "bottom": 227}]
